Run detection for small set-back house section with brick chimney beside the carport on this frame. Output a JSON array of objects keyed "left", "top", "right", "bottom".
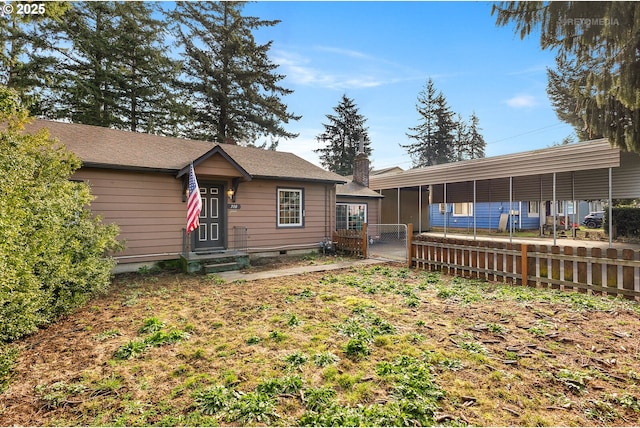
[{"left": 336, "top": 152, "right": 383, "bottom": 230}]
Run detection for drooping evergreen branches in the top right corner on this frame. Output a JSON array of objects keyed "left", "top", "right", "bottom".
[{"left": 492, "top": 1, "right": 640, "bottom": 152}]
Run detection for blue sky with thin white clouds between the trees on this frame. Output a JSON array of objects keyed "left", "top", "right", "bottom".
[{"left": 238, "top": 1, "right": 574, "bottom": 169}]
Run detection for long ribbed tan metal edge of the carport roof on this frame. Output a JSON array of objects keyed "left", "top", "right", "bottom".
[{"left": 369, "top": 139, "right": 620, "bottom": 189}]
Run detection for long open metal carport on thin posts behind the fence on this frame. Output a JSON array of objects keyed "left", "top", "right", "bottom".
[{"left": 369, "top": 139, "right": 640, "bottom": 246}]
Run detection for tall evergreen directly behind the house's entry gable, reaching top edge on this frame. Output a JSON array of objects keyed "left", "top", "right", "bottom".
[{"left": 169, "top": 1, "right": 300, "bottom": 144}]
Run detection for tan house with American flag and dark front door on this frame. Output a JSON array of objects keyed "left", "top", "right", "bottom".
[{"left": 27, "top": 120, "right": 346, "bottom": 271}]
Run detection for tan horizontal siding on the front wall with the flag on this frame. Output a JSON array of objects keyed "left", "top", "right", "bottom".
[{"left": 74, "top": 168, "right": 335, "bottom": 263}]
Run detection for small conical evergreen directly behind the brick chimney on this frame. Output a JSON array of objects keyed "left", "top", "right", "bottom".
[{"left": 314, "top": 94, "right": 371, "bottom": 175}]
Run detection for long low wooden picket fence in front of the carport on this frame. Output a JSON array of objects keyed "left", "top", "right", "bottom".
[{"left": 411, "top": 237, "right": 640, "bottom": 300}]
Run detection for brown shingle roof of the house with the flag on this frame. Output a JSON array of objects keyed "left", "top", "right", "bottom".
[{"left": 26, "top": 120, "right": 346, "bottom": 183}]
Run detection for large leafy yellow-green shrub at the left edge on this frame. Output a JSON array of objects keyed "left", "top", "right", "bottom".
[{"left": 0, "top": 87, "right": 119, "bottom": 342}]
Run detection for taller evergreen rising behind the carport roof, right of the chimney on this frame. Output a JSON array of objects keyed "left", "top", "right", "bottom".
[{"left": 401, "top": 79, "right": 455, "bottom": 168}]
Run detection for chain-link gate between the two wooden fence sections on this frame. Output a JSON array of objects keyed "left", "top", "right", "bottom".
[{"left": 367, "top": 224, "right": 408, "bottom": 263}]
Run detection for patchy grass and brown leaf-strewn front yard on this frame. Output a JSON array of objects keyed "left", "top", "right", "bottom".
[{"left": 0, "top": 260, "right": 640, "bottom": 426}]
